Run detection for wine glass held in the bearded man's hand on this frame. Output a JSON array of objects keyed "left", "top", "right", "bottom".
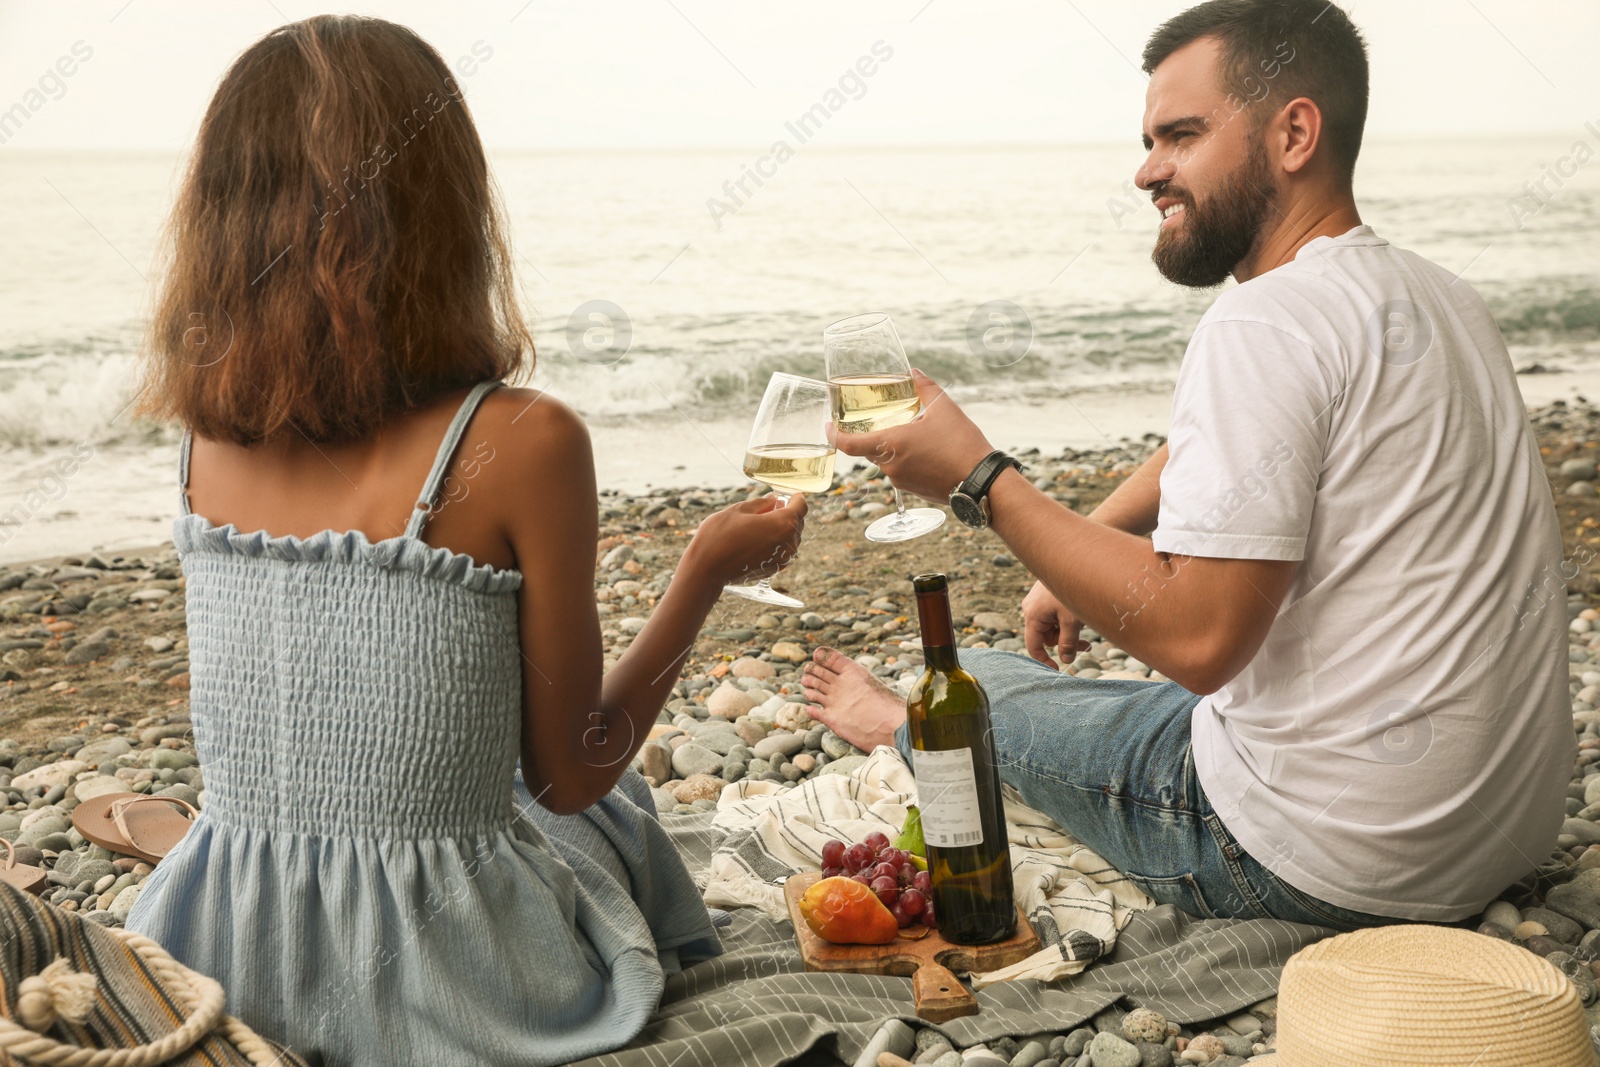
[{"left": 822, "top": 314, "right": 944, "bottom": 542}]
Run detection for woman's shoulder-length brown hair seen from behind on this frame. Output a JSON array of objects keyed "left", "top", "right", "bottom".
[{"left": 139, "top": 16, "right": 533, "bottom": 446}]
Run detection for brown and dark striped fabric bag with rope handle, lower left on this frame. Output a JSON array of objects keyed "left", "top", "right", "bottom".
[{"left": 0, "top": 883, "right": 307, "bottom": 1067}]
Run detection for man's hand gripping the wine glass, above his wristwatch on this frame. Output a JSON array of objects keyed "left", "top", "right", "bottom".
[{"left": 834, "top": 371, "right": 994, "bottom": 501}]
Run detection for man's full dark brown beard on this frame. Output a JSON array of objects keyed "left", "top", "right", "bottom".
[{"left": 1150, "top": 147, "right": 1277, "bottom": 290}]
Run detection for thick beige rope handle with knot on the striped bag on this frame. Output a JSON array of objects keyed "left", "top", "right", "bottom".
[{"left": 0, "top": 927, "right": 282, "bottom": 1067}]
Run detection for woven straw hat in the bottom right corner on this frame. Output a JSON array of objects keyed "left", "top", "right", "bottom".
[{"left": 1251, "top": 923, "right": 1595, "bottom": 1067}]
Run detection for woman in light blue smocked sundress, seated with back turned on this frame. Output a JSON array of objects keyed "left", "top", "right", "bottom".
[{"left": 128, "top": 16, "right": 805, "bottom": 1065}]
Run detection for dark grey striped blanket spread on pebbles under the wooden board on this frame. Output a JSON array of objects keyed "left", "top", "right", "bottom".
[{"left": 563, "top": 813, "right": 1333, "bottom": 1067}]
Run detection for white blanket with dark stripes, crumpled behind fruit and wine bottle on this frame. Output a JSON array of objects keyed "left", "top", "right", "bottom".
[{"left": 704, "top": 747, "right": 1155, "bottom": 989}]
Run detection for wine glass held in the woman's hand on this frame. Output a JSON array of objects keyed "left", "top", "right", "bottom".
[{"left": 723, "top": 374, "right": 835, "bottom": 608}]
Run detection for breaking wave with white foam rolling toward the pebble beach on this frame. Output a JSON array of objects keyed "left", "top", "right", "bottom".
[{"left": 0, "top": 277, "right": 1600, "bottom": 448}]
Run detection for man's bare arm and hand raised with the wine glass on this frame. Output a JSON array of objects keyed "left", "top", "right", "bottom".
[{"left": 837, "top": 373, "right": 1296, "bottom": 693}]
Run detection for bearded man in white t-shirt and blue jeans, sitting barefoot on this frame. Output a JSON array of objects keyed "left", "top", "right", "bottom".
[{"left": 806, "top": 0, "right": 1576, "bottom": 929}]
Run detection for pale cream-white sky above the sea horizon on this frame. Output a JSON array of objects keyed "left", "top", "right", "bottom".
[{"left": 0, "top": 0, "right": 1600, "bottom": 152}]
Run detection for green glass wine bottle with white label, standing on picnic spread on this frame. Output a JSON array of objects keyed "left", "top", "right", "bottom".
[{"left": 906, "top": 574, "right": 1016, "bottom": 945}]
